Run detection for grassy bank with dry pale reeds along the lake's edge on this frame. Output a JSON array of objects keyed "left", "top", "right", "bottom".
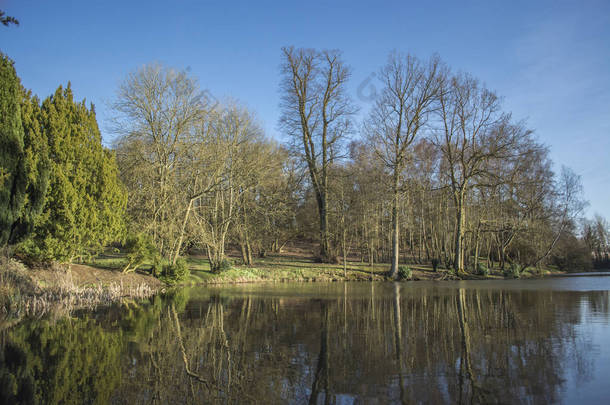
[{"left": 0, "top": 253, "right": 564, "bottom": 316}]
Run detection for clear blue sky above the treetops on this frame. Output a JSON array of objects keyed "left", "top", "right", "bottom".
[{"left": 0, "top": 0, "right": 610, "bottom": 219}]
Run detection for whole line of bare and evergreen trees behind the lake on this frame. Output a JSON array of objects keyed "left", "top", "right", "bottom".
[{"left": 0, "top": 47, "right": 610, "bottom": 275}]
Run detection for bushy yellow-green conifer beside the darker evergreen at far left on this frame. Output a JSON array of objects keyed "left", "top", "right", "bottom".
[{"left": 23, "top": 84, "right": 127, "bottom": 261}]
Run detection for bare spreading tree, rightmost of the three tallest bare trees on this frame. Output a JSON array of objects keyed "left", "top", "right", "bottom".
[{"left": 435, "top": 74, "right": 531, "bottom": 272}]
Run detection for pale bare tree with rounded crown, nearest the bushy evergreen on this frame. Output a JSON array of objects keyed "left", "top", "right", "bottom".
[{"left": 113, "top": 64, "right": 209, "bottom": 259}]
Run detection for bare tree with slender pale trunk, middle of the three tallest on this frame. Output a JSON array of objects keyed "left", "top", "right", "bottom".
[{"left": 366, "top": 53, "right": 445, "bottom": 277}]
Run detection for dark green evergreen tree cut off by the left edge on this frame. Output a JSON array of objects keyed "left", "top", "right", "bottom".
[{"left": 0, "top": 53, "right": 27, "bottom": 246}]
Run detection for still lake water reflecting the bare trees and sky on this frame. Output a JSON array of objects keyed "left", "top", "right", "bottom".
[{"left": 0, "top": 277, "right": 610, "bottom": 404}]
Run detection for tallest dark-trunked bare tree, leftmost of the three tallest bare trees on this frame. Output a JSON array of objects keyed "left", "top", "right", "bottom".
[{"left": 280, "top": 47, "right": 355, "bottom": 262}]
